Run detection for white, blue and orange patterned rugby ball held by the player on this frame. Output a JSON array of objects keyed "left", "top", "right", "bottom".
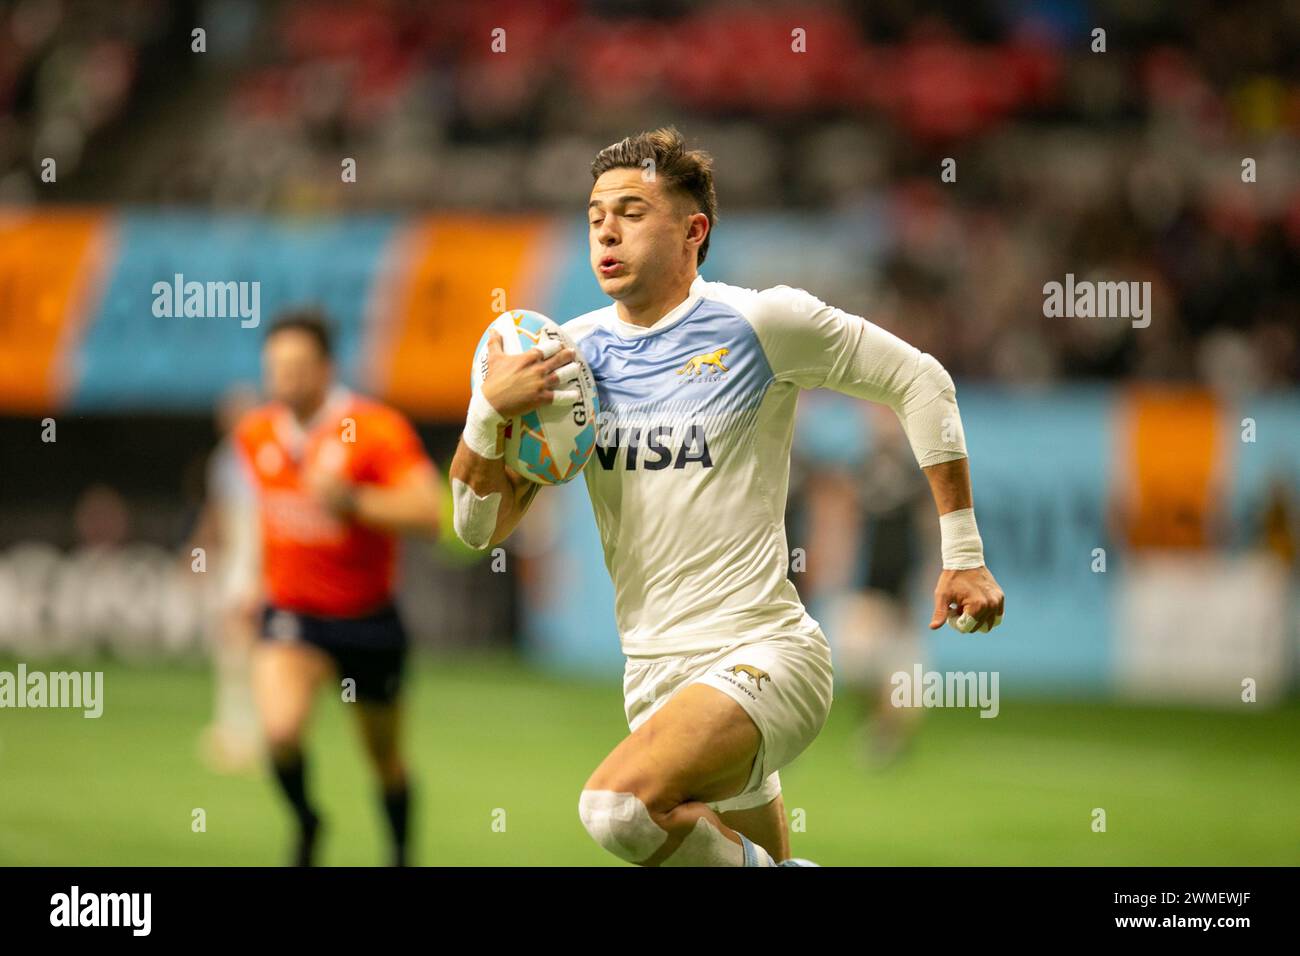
[{"left": 469, "top": 308, "right": 601, "bottom": 485}]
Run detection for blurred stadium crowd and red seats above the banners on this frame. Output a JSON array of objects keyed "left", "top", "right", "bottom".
[{"left": 0, "top": 0, "right": 1300, "bottom": 392}]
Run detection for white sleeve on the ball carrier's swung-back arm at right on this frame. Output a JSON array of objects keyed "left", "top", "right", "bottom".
[{"left": 751, "top": 286, "right": 966, "bottom": 468}]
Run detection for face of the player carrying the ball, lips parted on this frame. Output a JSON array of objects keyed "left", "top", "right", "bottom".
[{"left": 586, "top": 169, "right": 694, "bottom": 299}]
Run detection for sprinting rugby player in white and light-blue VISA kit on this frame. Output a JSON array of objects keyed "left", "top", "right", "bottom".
[{"left": 451, "top": 129, "right": 1004, "bottom": 866}]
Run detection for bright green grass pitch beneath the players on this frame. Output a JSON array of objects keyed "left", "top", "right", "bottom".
[{"left": 0, "top": 657, "right": 1300, "bottom": 866}]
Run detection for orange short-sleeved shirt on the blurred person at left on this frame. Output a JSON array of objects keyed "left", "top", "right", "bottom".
[{"left": 235, "top": 389, "right": 433, "bottom": 618}]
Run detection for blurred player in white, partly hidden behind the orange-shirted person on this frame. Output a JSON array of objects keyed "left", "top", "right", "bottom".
[{"left": 186, "top": 385, "right": 263, "bottom": 773}]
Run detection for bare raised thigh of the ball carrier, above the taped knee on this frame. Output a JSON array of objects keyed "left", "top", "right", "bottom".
[{"left": 586, "top": 684, "right": 762, "bottom": 812}]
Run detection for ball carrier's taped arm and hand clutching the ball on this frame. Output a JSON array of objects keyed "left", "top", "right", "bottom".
[{"left": 451, "top": 330, "right": 575, "bottom": 549}]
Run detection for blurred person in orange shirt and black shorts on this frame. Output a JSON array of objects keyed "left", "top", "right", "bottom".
[{"left": 237, "top": 311, "right": 439, "bottom": 866}]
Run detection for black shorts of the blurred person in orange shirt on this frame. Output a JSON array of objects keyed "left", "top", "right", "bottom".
[{"left": 261, "top": 605, "right": 407, "bottom": 704}]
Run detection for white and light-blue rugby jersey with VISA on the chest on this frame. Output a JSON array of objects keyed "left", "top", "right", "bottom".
[{"left": 564, "top": 276, "right": 965, "bottom": 657}]
